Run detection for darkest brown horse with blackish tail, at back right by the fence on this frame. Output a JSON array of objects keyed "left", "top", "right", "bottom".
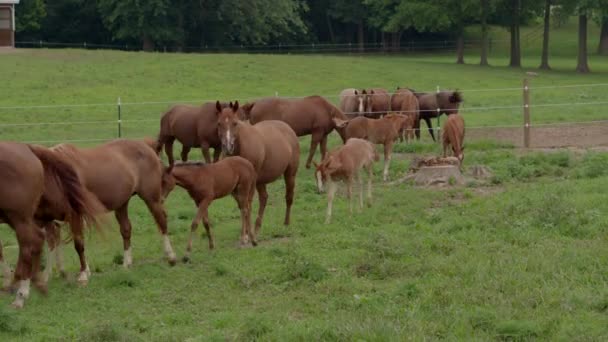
[{"left": 409, "top": 89, "right": 463, "bottom": 141}]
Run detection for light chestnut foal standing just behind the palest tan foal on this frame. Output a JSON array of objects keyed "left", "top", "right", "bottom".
[{"left": 335, "top": 113, "right": 407, "bottom": 181}]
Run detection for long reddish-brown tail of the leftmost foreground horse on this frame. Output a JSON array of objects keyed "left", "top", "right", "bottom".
[{"left": 29, "top": 145, "right": 103, "bottom": 238}]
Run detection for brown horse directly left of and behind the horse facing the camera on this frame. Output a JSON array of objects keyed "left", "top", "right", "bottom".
[{"left": 156, "top": 102, "right": 226, "bottom": 166}]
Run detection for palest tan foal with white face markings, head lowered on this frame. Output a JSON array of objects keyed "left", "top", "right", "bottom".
[{"left": 315, "top": 138, "right": 378, "bottom": 224}]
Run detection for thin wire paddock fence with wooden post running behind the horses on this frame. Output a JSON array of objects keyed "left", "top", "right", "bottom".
[{"left": 0, "top": 79, "right": 608, "bottom": 148}]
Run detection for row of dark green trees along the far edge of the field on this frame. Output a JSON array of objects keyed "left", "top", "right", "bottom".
[{"left": 17, "top": 0, "right": 608, "bottom": 72}]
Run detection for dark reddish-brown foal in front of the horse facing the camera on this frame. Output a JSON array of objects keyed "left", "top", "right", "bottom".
[{"left": 163, "top": 157, "right": 257, "bottom": 261}]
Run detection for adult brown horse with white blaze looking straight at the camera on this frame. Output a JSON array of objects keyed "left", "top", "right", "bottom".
[{"left": 216, "top": 101, "right": 300, "bottom": 235}]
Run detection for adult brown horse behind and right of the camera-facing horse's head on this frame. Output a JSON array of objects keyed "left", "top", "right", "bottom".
[{"left": 239, "top": 96, "right": 347, "bottom": 168}]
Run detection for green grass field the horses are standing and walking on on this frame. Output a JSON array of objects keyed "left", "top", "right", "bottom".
[{"left": 0, "top": 19, "right": 608, "bottom": 341}]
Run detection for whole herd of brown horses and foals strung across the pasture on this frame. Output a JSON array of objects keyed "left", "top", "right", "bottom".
[{"left": 0, "top": 88, "right": 464, "bottom": 308}]
